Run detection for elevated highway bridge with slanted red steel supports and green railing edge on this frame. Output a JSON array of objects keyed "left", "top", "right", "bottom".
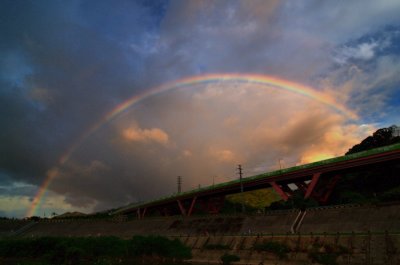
[{"left": 113, "top": 144, "right": 400, "bottom": 219}]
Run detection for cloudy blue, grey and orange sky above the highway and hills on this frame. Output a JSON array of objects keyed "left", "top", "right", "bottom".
[{"left": 0, "top": 0, "right": 400, "bottom": 218}]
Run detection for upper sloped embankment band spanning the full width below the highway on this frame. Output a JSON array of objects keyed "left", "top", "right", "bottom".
[{"left": 0, "top": 204, "right": 400, "bottom": 238}]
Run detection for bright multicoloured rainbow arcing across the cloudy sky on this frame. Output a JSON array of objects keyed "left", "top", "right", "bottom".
[{"left": 27, "top": 73, "right": 357, "bottom": 216}]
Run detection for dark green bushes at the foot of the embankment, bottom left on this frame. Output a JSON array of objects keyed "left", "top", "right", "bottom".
[{"left": 0, "top": 236, "right": 191, "bottom": 264}]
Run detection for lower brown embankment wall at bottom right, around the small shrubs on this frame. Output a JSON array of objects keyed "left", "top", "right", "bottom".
[{"left": 178, "top": 233, "right": 400, "bottom": 265}]
